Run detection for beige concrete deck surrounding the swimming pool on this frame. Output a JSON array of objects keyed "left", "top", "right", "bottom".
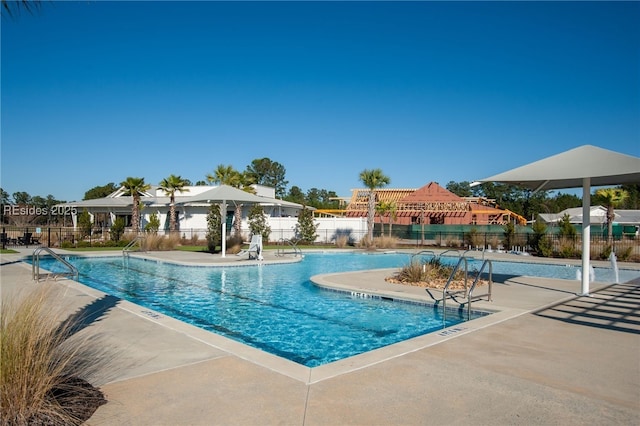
[{"left": 0, "top": 250, "right": 640, "bottom": 425}]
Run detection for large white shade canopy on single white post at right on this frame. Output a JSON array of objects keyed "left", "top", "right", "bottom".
[{"left": 471, "top": 145, "right": 640, "bottom": 296}]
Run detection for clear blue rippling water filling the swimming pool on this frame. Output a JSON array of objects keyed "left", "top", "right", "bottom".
[{"left": 31, "top": 253, "right": 640, "bottom": 367}]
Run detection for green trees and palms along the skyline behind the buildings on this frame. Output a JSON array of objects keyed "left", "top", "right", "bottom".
[{"left": 0, "top": 158, "right": 640, "bottom": 229}]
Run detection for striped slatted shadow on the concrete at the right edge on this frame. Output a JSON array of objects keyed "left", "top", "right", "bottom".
[{"left": 534, "top": 282, "right": 640, "bottom": 334}]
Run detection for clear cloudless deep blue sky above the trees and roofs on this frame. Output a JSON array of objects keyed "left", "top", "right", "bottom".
[{"left": 1, "top": 1, "right": 640, "bottom": 201}]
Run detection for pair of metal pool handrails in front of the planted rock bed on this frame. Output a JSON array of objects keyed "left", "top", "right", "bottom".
[{"left": 425, "top": 256, "right": 493, "bottom": 321}]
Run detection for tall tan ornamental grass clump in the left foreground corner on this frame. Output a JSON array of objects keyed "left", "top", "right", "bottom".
[{"left": 0, "top": 286, "right": 108, "bottom": 425}]
